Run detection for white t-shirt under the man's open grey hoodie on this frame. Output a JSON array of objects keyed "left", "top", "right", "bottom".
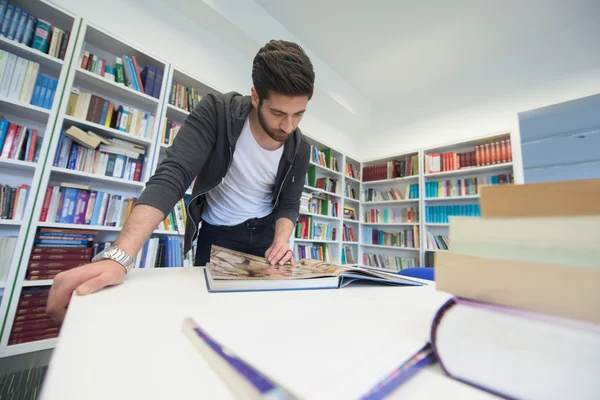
[{"left": 202, "top": 118, "right": 283, "bottom": 226}]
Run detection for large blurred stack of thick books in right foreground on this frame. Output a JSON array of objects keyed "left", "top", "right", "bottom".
[{"left": 431, "top": 180, "right": 600, "bottom": 399}]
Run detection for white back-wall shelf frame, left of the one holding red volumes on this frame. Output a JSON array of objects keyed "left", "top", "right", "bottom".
[{"left": 358, "top": 150, "right": 423, "bottom": 268}]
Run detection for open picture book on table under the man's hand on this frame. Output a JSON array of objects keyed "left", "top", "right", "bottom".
[{"left": 205, "top": 246, "right": 423, "bottom": 292}]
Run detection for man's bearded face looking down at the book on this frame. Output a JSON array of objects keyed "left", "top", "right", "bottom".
[{"left": 252, "top": 89, "right": 308, "bottom": 142}]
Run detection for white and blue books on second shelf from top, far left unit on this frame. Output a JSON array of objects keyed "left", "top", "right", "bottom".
[{"left": 0, "top": 50, "right": 58, "bottom": 109}]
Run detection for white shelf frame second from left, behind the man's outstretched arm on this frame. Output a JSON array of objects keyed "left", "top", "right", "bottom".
[{"left": 0, "top": 17, "right": 172, "bottom": 354}]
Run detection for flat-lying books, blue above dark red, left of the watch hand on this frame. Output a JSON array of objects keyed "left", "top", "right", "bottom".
[{"left": 27, "top": 228, "right": 98, "bottom": 281}]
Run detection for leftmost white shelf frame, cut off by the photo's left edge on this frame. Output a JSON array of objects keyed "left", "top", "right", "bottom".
[{"left": 0, "top": 0, "right": 81, "bottom": 357}]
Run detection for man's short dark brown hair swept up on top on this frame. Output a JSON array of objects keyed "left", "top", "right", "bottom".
[{"left": 252, "top": 40, "right": 315, "bottom": 100}]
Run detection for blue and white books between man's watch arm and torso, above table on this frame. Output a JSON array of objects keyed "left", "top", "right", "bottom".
[{"left": 135, "top": 236, "right": 188, "bottom": 268}]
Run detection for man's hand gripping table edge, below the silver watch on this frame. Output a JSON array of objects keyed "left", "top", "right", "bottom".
[{"left": 46, "top": 260, "right": 126, "bottom": 324}]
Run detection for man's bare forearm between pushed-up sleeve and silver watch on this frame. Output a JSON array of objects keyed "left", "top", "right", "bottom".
[{"left": 115, "top": 204, "right": 165, "bottom": 257}]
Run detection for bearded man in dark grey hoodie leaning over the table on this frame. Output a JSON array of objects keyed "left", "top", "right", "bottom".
[{"left": 47, "top": 41, "right": 315, "bottom": 321}]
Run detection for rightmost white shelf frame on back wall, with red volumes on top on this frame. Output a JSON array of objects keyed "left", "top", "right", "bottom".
[{"left": 421, "top": 130, "right": 515, "bottom": 266}]
